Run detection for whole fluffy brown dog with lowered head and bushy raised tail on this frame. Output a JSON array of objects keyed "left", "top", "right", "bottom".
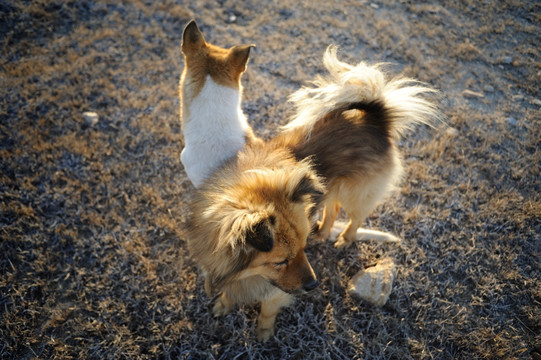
[{"left": 188, "top": 44, "right": 438, "bottom": 340}]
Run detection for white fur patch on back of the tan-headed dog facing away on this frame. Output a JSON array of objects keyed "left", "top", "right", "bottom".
[{"left": 180, "top": 76, "right": 248, "bottom": 187}]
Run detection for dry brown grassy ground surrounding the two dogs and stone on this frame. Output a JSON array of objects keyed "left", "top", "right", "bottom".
[{"left": 0, "top": 0, "right": 541, "bottom": 360}]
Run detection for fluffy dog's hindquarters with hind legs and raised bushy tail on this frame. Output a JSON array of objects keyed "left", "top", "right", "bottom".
[{"left": 275, "top": 47, "right": 440, "bottom": 248}]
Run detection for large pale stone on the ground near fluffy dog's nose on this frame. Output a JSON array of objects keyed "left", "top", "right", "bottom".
[{"left": 348, "top": 258, "right": 396, "bottom": 306}]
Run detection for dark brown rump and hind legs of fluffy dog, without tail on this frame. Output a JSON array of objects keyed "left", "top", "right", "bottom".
[{"left": 275, "top": 103, "right": 402, "bottom": 247}]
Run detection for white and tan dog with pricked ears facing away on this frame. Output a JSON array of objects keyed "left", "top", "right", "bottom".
[{"left": 179, "top": 20, "right": 260, "bottom": 188}]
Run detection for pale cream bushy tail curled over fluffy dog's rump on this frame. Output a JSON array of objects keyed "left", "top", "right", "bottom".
[{"left": 283, "top": 45, "right": 441, "bottom": 137}]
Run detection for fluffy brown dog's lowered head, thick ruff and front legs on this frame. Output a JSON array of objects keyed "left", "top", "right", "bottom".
[{"left": 188, "top": 142, "right": 324, "bottom": 340}]
